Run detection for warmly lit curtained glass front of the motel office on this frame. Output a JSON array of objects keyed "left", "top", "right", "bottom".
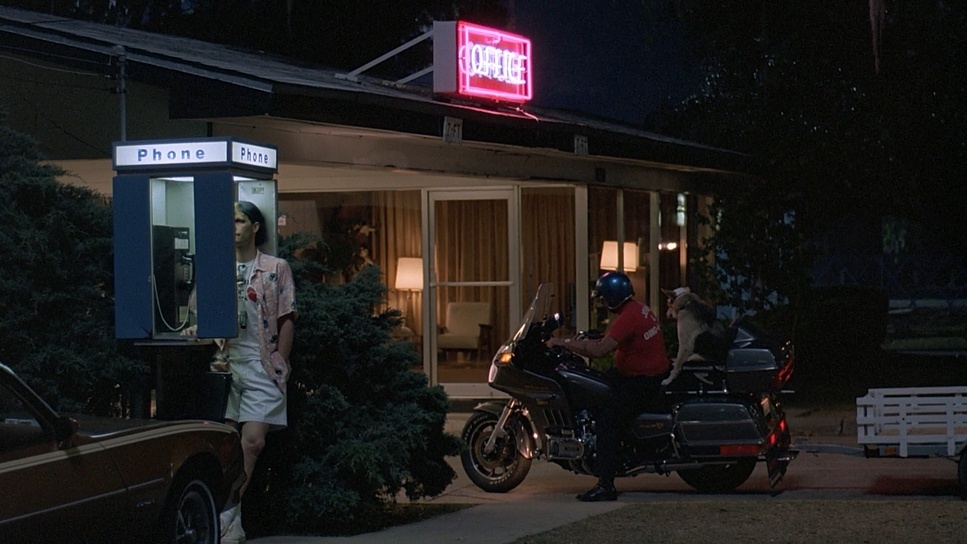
[{"left": 268, "top": 183, "right": 698, "bottom": 394}]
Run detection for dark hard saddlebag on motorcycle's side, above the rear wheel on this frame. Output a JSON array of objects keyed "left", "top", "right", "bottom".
[{"left": 675, "top": 398, "right": 768, "bottom": 455}]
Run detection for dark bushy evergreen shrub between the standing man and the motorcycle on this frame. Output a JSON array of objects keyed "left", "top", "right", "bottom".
[{"left": 243, "top": 233, "right": 461, "bottom": 532}]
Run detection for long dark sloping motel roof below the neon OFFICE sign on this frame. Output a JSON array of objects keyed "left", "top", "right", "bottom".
[{"left": 0, "top": 7, "right": 754, "bottom": 189}]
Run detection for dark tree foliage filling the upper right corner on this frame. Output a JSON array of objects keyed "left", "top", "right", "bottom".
[{"left": 650, "top": 0, "right": 967, "bottom": 314}]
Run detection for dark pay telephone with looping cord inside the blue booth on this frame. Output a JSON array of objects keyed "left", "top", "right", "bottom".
[{"left": 151, "top": 225, "right": 195, "bottom": 332}]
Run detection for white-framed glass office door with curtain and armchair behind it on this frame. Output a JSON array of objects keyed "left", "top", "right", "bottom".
[{"left": 423, "top": 188, "right": 520, "bottom": 398}]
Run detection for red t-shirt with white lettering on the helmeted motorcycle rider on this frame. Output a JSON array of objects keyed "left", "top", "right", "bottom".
[{"left": 607, "top": 300, "right": 671, "bottom": 377}]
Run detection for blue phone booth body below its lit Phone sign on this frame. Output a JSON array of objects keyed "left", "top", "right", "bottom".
[{"left": 113, "top": 172, "right": 237, "bottom": 340}]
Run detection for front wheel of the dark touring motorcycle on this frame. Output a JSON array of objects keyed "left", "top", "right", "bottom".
[{"left": 460, "top": 412, "right": 531, "bottom": 493}]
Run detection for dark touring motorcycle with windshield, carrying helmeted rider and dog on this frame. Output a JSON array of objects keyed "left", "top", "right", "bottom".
[{"left": 461, "top": 283, "right": 797, "bottom": 493}]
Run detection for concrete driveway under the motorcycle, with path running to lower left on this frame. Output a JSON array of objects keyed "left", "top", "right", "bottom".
[{"left": 248, "top": 406, "right": 959, "bottom": 544}]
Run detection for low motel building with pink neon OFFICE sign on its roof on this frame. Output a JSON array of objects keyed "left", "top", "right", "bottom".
[{"left": 0, "top": 7, "right": 750, "bottom": 398}]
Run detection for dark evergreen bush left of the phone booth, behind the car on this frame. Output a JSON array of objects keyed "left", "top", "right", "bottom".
[{"left": 0, "top": 106, "right": 144, "bottom": 415}]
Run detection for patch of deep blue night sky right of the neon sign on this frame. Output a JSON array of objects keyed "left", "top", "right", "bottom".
[{"left": 514, "top": 0, "right": 701, "bottom": 124}]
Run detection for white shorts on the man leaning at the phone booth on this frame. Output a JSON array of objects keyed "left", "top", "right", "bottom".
[{"left": 225, "top": 360, "right": 288, "bottom": 431}]
